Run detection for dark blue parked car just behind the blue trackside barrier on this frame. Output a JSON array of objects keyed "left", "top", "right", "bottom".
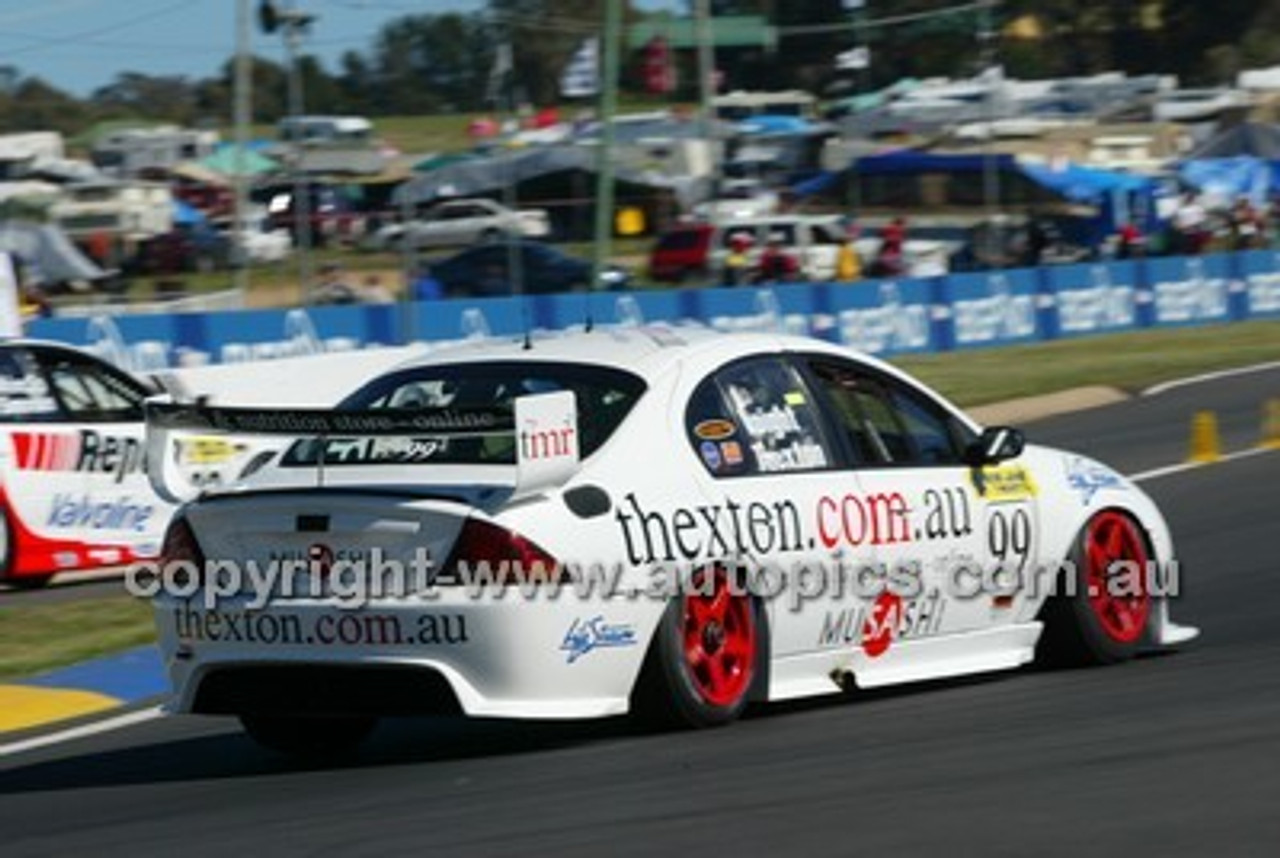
[{"left": 431, "top": 241, "right": 630, "bottom": 297}]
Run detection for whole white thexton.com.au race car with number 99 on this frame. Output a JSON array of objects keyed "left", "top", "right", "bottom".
[{"left": 148, "top": 328, "right": 1197, "bottom": 752}]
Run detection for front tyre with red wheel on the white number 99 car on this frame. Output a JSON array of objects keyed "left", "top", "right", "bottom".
[{"left": 1037, "top": 510, "right": 1151, "bottom": 666}]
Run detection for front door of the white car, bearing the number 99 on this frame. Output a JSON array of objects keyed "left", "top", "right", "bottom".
[{"left": 805, "top": 356, "right": 1038, "bottom": 656}]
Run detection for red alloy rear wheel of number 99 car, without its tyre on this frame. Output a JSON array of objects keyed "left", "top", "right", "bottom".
[{"left": 684, "top": 570, "right": 755, "bottom": 707}]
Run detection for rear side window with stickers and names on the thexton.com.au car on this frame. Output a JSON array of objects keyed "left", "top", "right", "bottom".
[{"left": 687, "top": 359, "right": 835, "bottom": 475}]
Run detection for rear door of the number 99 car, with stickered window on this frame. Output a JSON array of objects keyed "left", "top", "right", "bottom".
[{"left": 685, "top": 355, "right": 864, "bottom": 658}]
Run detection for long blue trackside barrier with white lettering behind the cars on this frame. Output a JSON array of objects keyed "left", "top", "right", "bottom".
[{"left": 28, "top": 250, "right": 1280, "bottom": 371}]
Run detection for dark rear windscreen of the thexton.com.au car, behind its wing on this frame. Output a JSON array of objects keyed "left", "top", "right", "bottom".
[{"left": 280, "top": 361, "right": 645, "bottom": 466}]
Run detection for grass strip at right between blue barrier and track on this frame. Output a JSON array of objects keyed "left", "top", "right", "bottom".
[{"left": 893, "top": 321, "right": 1280, "bottom": 407}]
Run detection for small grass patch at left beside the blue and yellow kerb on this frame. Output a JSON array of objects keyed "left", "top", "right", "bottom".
[{"left": 0, "top": 594, "right": 155, "bottom": 680}]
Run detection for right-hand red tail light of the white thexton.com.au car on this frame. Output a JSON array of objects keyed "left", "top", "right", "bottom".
[{"left": 436, "top": 519, "right": 570, "bottom": 585}]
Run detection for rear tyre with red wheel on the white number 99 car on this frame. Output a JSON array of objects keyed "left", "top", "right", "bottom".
[{"left": 631, "top": 569, "right": 767, "bottom": 727}]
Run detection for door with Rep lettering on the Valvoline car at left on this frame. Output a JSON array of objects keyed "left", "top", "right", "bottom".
[{"left": 33, "top": 347, "right": 169, "bottom": 563}]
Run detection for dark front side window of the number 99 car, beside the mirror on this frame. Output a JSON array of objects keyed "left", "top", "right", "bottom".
[{"left": 812, "top": 361, "right": 965, "bottom": 466}]
